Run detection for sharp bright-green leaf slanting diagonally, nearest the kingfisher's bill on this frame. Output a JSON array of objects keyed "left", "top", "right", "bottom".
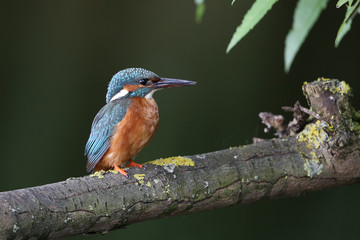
[{"left": 226, "top": 0, "right": 278, "bottom": 53}]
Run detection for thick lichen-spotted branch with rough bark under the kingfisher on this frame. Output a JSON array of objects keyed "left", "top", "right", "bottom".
[{"left": 0, "top": 79, "right": 360, "bottom": 239}]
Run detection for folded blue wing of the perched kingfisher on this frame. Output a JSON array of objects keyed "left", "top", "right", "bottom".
[{"left": 85, "top": 99, "right": 131, "bottom": 172}]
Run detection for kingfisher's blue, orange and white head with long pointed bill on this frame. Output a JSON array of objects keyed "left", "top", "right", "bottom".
[{"left": 106, "top": 68, "right": 196, "bottom": 103}]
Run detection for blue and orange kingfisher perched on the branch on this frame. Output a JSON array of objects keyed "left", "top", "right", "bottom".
[{"left": 85, "top": 68, "right": 196, "bottom": 176}]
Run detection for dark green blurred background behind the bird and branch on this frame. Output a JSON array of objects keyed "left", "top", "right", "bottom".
[{"left": 0, "top": 0, "right": 360, "bottom": 240}]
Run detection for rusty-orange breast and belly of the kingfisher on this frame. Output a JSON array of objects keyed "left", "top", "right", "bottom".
[{"left": 94, "top": 97, "right": 159, "bottom": 171}]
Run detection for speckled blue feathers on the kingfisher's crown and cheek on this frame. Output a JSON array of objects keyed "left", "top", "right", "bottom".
[{"left": 106, "top": 68, "right": 160, "bottom": 103}]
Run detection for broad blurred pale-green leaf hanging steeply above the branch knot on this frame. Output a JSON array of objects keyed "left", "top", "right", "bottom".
[{"left": 284, "top": 0, "right": 328, "bottom": 72}]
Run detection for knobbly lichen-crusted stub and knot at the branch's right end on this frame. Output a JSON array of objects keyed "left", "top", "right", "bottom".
[{"left": 257, "top": 78, "right": 360, "bottom": 177}]
